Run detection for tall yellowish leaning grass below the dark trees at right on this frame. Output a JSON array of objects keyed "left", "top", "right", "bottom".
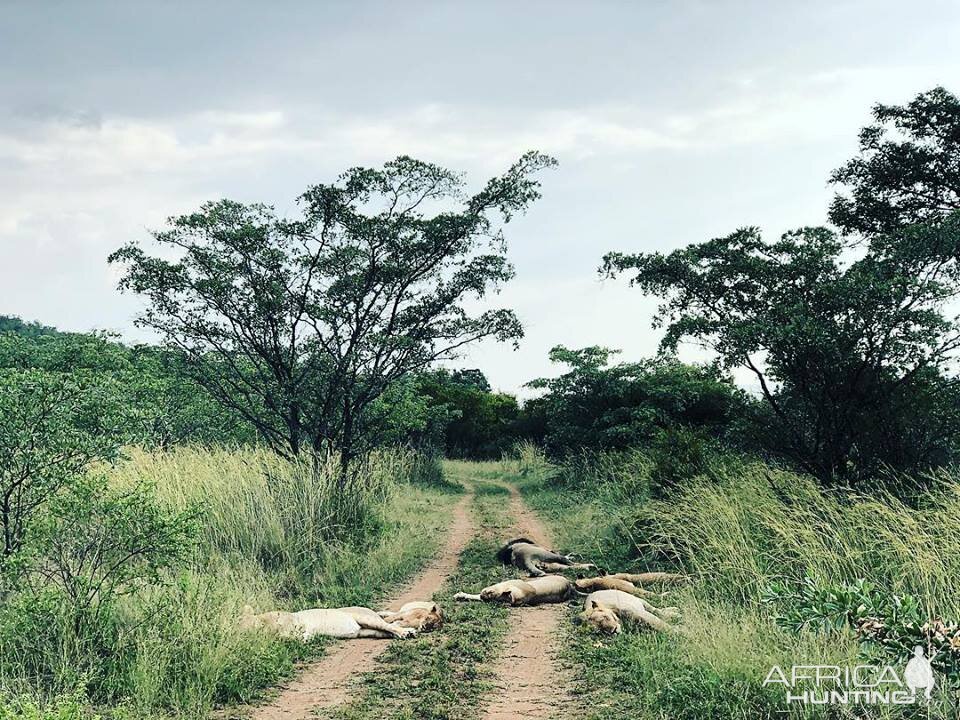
[{"left": 633, "top": 463, "right": 960, "bottom": 616}]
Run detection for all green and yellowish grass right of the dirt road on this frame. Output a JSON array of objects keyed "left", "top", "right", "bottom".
[{"left": 514, "top": 451, "right": 960, "bottom": 720}]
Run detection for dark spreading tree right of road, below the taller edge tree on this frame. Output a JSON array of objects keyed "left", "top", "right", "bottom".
[{"left": 603, "top": 219, "right": 960, "bottom": 479}]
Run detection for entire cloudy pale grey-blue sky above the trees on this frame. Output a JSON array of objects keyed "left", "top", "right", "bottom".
[{"left": 0, "top": 0, "right": 960, "bottom": 394}]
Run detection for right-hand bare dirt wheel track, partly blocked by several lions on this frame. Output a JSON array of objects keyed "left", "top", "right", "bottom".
[{"left": 481, "top": 485, "right": 573, "bottom": 720}]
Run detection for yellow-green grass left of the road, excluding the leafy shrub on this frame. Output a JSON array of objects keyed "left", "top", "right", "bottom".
[{"left": 0, "top": 448, "right": 457, "bottom": 719}]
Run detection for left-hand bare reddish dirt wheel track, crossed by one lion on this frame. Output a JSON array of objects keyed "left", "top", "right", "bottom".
[{"left": 250, "top": 491, "right": 474, "bottom": 720}]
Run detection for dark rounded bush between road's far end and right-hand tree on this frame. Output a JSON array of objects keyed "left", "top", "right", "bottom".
[{"left": 525, "top": 346, "right": 747, "bottom": 456}]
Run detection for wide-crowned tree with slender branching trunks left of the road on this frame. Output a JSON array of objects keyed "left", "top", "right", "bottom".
[{"left": 110, "top": 152, "right": 555, "bottom": 478}]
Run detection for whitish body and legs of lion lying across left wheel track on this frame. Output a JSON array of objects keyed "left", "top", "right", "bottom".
[{"left": 240, "top": 605, "right": 417, "bottom": 642}]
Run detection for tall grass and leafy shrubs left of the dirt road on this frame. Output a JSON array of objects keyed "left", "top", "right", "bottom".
[{"left": 0, "top": 447, "right": 454, "bottom": 720}]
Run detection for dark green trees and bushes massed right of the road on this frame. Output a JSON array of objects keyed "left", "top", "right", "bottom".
[{"left": 476, "top": 88, "right": 960, "bottom": 488}]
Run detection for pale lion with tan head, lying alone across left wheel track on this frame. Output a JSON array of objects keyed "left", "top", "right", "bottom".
[{"left": 240, "top": 603, "right": 442, "bottom": 642}]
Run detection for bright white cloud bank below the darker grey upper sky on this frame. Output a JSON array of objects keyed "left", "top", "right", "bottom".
[{"left": 0, "top": 59, "right": 952, "bottom": 389}]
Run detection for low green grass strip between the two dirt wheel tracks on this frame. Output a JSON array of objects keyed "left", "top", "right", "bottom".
[{"left": 335, "top": 463, "right": 513, "bottom": 720}]
